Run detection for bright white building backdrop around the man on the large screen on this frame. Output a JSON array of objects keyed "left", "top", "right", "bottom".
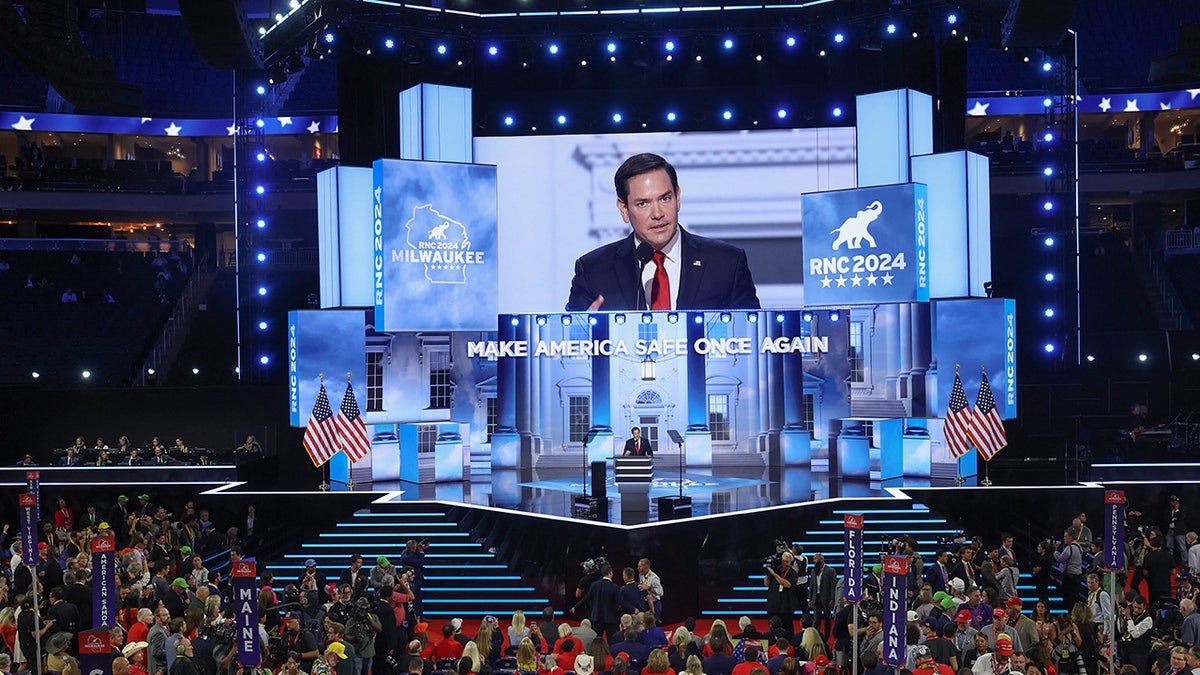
[{"left": 475, "top": 127, "right": 856, "bottom": 312}]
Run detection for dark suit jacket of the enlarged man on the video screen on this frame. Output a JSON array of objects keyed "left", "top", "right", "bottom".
[{"left": 566, "top": 227, "right": 760, "bottom": 312}]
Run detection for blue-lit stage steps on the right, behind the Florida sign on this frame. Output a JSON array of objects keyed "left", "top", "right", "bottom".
[{"left": 701, "top": 496, "right": 1063, "bottom": 617}]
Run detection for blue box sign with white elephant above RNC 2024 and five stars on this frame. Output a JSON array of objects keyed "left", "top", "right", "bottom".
[{"left": 800, "top": 183, "right": 929, "bottom": 306}]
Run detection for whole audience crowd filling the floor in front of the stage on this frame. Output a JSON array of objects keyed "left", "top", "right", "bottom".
[{"left": 0, "top": 494, "right": 1200, "bottom": 675}]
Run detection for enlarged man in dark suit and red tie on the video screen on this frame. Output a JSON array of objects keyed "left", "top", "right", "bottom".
[{"left": 566, "top": 153, "right": 760, "bottom": 311}]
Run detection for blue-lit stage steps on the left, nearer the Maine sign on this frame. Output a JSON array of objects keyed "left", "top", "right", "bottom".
[{"left": 266, "top": 502, "right": 550, "bottom": 619}]
